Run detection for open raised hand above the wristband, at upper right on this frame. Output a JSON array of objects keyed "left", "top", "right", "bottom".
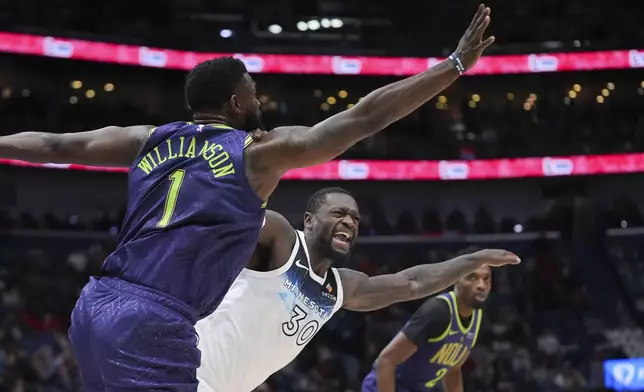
[{"left": 454, "top": 4, "right": 494, "bottom": 70}]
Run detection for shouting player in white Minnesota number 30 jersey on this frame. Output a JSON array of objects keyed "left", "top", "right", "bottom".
[{"left": 196, "top": 188, "right": 519, "bottom": 392}]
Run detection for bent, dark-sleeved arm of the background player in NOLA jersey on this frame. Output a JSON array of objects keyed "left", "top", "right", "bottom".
[{"left": 374, "top": 297, "right": 451, "bottom": 392}]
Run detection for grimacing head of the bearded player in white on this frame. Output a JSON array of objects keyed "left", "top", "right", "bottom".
[{"left": 304, "top": 188, "right": 360, "bottom": 262}]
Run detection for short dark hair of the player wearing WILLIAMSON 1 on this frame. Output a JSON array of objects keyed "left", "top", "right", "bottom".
[{"left": 185, "top": 57, "right": 248, "bottom": 112}]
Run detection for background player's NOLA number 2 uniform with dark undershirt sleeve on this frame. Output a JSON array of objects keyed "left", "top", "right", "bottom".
[{"left": 362, "top": 291, "right": 483, "bottom": 392}]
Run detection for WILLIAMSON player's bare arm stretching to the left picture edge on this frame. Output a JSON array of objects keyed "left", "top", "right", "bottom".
[{"left": 0, "top": 125, "right": 154, "bottom": 167}]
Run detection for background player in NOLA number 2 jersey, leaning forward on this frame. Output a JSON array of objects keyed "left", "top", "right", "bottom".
[{"left": 362, "top": 266, "right": 492, "bottom": 392}]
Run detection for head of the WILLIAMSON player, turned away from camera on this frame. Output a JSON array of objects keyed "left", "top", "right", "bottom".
[{"left": 185, "top": 57, "right": 262, "bottom": 130}]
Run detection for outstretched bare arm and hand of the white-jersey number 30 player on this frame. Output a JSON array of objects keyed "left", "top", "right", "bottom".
[{"left": 338, "top": 249, "right": 520, "bottom": 312}]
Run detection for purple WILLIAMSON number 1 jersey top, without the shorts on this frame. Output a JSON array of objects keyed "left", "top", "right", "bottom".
[{"left": 102, "top": 122, "right": 265, "bottom": 317}]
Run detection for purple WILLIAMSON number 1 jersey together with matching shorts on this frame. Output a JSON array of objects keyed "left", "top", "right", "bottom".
[{"left": 69, "top": 122, "right": 264, "bottom": 392}]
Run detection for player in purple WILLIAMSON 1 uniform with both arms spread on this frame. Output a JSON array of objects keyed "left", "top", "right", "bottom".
[{"left": 0, "top": 5, "right": 494, "bottom": 391}]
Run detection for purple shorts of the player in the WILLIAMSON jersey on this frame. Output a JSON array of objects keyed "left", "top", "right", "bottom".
[{"left": 69, "top": 277, "right": 201, "bottom": 392}]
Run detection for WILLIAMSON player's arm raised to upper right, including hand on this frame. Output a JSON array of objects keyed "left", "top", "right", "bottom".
[{"left": 246, "top": 5, "right": 494, "bottom": 198}]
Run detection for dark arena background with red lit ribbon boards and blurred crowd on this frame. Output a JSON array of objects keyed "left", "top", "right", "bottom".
[{"left": 0, "top": 0, "right": 644, "bottom": 392}]
